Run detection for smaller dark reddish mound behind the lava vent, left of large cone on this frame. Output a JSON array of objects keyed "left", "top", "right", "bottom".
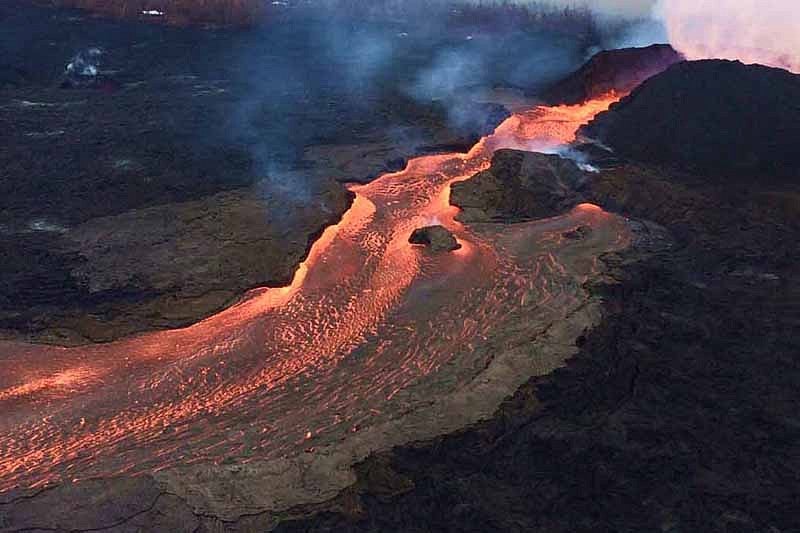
[{"left": 541, "top": 44, "right": 684, "bottom": 105}]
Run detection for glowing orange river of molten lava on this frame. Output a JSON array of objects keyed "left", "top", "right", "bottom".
[{"left": 0, "top": 91, "right": 627, "bottom": 491}]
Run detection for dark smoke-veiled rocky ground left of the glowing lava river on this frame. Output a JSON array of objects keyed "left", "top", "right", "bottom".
[{"left": 0, "top": 0, "right": 552, "bottom": 344}]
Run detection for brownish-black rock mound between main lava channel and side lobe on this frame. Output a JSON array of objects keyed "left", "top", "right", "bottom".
[{"left": 450, "top": 150, "right": 586, "bottom": 222}]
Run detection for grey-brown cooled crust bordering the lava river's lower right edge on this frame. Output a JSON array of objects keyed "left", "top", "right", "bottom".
[{"left": 0, "top": 185, "right": 636, "bottom": 532}]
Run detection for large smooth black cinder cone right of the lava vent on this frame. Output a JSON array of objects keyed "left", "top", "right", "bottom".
[{"left": 581, "top": 60, "right": 800, "bottom": 179}]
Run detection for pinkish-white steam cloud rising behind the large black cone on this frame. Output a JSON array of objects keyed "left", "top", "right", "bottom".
[{"left": 656, "top": 0, "right": 800, "bottom": 72}]
